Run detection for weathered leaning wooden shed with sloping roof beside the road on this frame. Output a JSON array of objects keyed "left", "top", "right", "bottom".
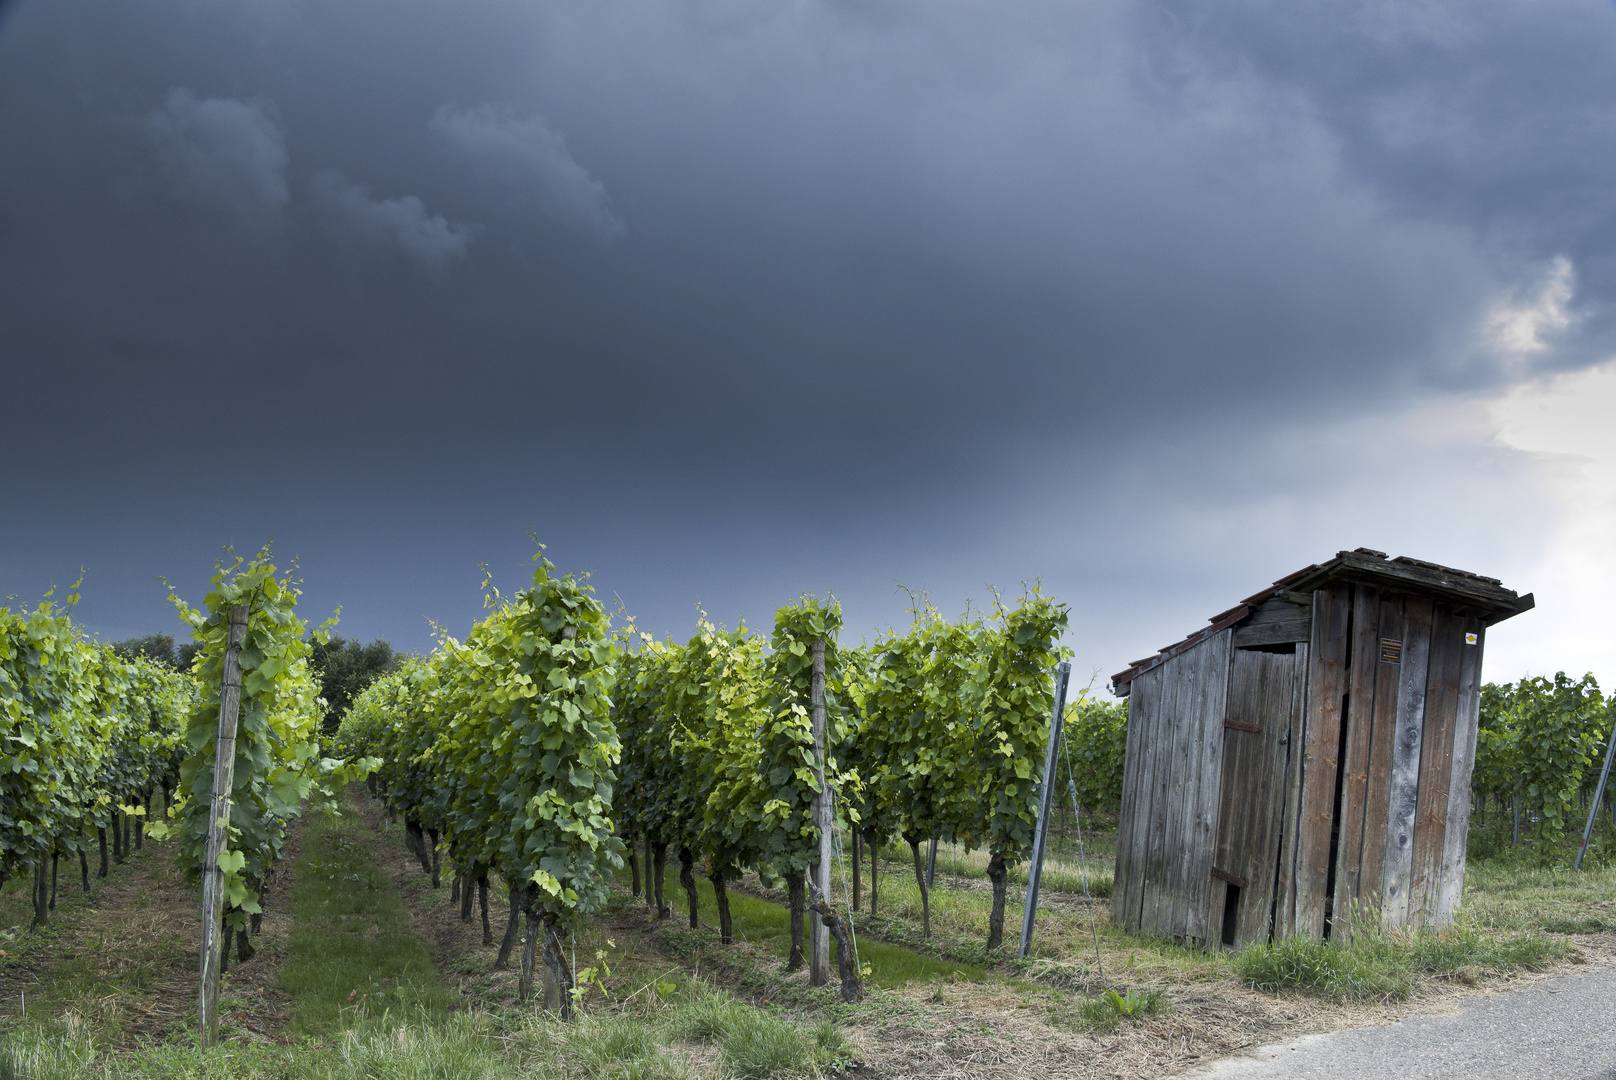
[{"left": 1112, "top": 548, "right": 1532, "bottom": 947}]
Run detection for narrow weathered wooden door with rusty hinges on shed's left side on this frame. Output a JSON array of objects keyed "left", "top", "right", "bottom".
[{"left": 1209, "top": 645, "right": 1307, "bottom": 947}]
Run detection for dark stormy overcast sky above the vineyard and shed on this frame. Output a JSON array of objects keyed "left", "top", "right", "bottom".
[{"left": 0, "top": 0, "right": 1616, "bottom": 681}]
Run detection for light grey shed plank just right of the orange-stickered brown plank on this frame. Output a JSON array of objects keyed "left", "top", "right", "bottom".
[{"left": 1380, "top": 597, "right": 1432, "bottom": 928}]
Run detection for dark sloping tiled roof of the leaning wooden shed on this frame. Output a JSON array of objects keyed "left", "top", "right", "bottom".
[{"left": 1112, "top": 548, "right": 1535, "bottom": 694}]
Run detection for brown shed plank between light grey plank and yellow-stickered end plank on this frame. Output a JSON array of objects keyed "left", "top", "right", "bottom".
[{"left": 1409, "top": 605, "right": 1464, "bottom": 925}]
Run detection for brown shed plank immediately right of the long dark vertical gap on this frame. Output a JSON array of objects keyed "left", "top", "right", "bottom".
[{"left": 1330, "top": 585, "right": 1380, "bottom": 943}]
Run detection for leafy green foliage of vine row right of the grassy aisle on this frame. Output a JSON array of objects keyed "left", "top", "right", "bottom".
[{"left": 338, "top": 546, "right": 624, "bottom": 922}]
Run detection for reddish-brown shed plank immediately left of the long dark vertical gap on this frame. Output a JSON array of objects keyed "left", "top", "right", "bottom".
[{"left": 1294, "top": 584, "right": 1353, "bottom": 938}]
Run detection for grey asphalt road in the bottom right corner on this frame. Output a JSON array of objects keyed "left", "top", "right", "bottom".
[{"left": 1191, "top": 967, "right": 1616, "bottom": 1080}]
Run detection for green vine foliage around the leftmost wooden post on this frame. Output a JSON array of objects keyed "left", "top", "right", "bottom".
[{"left": 158, "top": 548, "right": 339, "bottom": 926}]
